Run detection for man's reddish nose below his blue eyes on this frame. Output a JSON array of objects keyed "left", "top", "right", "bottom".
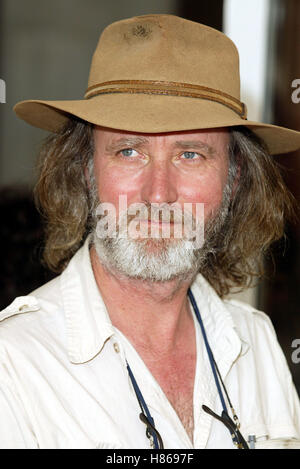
[{"left": 141, "top": 161, "right": 178, "bottom": 204}]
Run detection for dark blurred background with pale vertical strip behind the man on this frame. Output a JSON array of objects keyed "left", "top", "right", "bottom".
[{"left": 0, "top": 0, "right": 300, "bottom": 394}]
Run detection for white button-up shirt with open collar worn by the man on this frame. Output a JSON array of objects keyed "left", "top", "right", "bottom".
[{"left": 0, "top": 242, "right": 300, "bottom": 449}]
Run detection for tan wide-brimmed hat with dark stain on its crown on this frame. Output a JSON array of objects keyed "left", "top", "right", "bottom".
[{"left": 14, "top": 15, "right": 300, "bottom": 154}]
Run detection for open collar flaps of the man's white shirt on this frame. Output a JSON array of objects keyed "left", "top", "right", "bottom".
[{"left": 61, "top": 238, "right": 246, "bottom": 368}]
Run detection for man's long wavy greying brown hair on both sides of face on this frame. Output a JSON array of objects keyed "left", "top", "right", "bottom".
[{"left": 35, "top": 118, "right": 294, "bottom": 297}]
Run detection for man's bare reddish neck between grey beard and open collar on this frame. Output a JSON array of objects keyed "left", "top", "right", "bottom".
[{"left": 90, "top": 247, "right": 193, "bottom": 354}]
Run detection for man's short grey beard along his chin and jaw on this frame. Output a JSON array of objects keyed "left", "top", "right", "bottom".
[{"left": 92, "top": 183, "right": 232, "bottom": 282}]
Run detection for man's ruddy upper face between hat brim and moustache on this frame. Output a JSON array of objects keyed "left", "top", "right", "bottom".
[{"left": 94, "top": 127, "right": 229, "bottom": 219}]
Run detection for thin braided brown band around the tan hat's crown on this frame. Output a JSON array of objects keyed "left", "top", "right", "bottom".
[{"left": 84, "top": 80, "right": 247, "bottom": 119}]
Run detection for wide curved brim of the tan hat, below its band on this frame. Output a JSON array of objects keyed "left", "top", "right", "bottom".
[{"left": 14, "top": 94, "right": 300, "bottom": 155}]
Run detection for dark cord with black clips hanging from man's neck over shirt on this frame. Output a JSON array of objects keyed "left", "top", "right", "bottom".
[{"left": 126, "top": 289, "right": 249, "bottom": 449}]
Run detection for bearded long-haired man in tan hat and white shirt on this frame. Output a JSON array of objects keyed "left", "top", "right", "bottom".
[{"left": 0, "top": 15, "right": 300, "bottom": 449}]
